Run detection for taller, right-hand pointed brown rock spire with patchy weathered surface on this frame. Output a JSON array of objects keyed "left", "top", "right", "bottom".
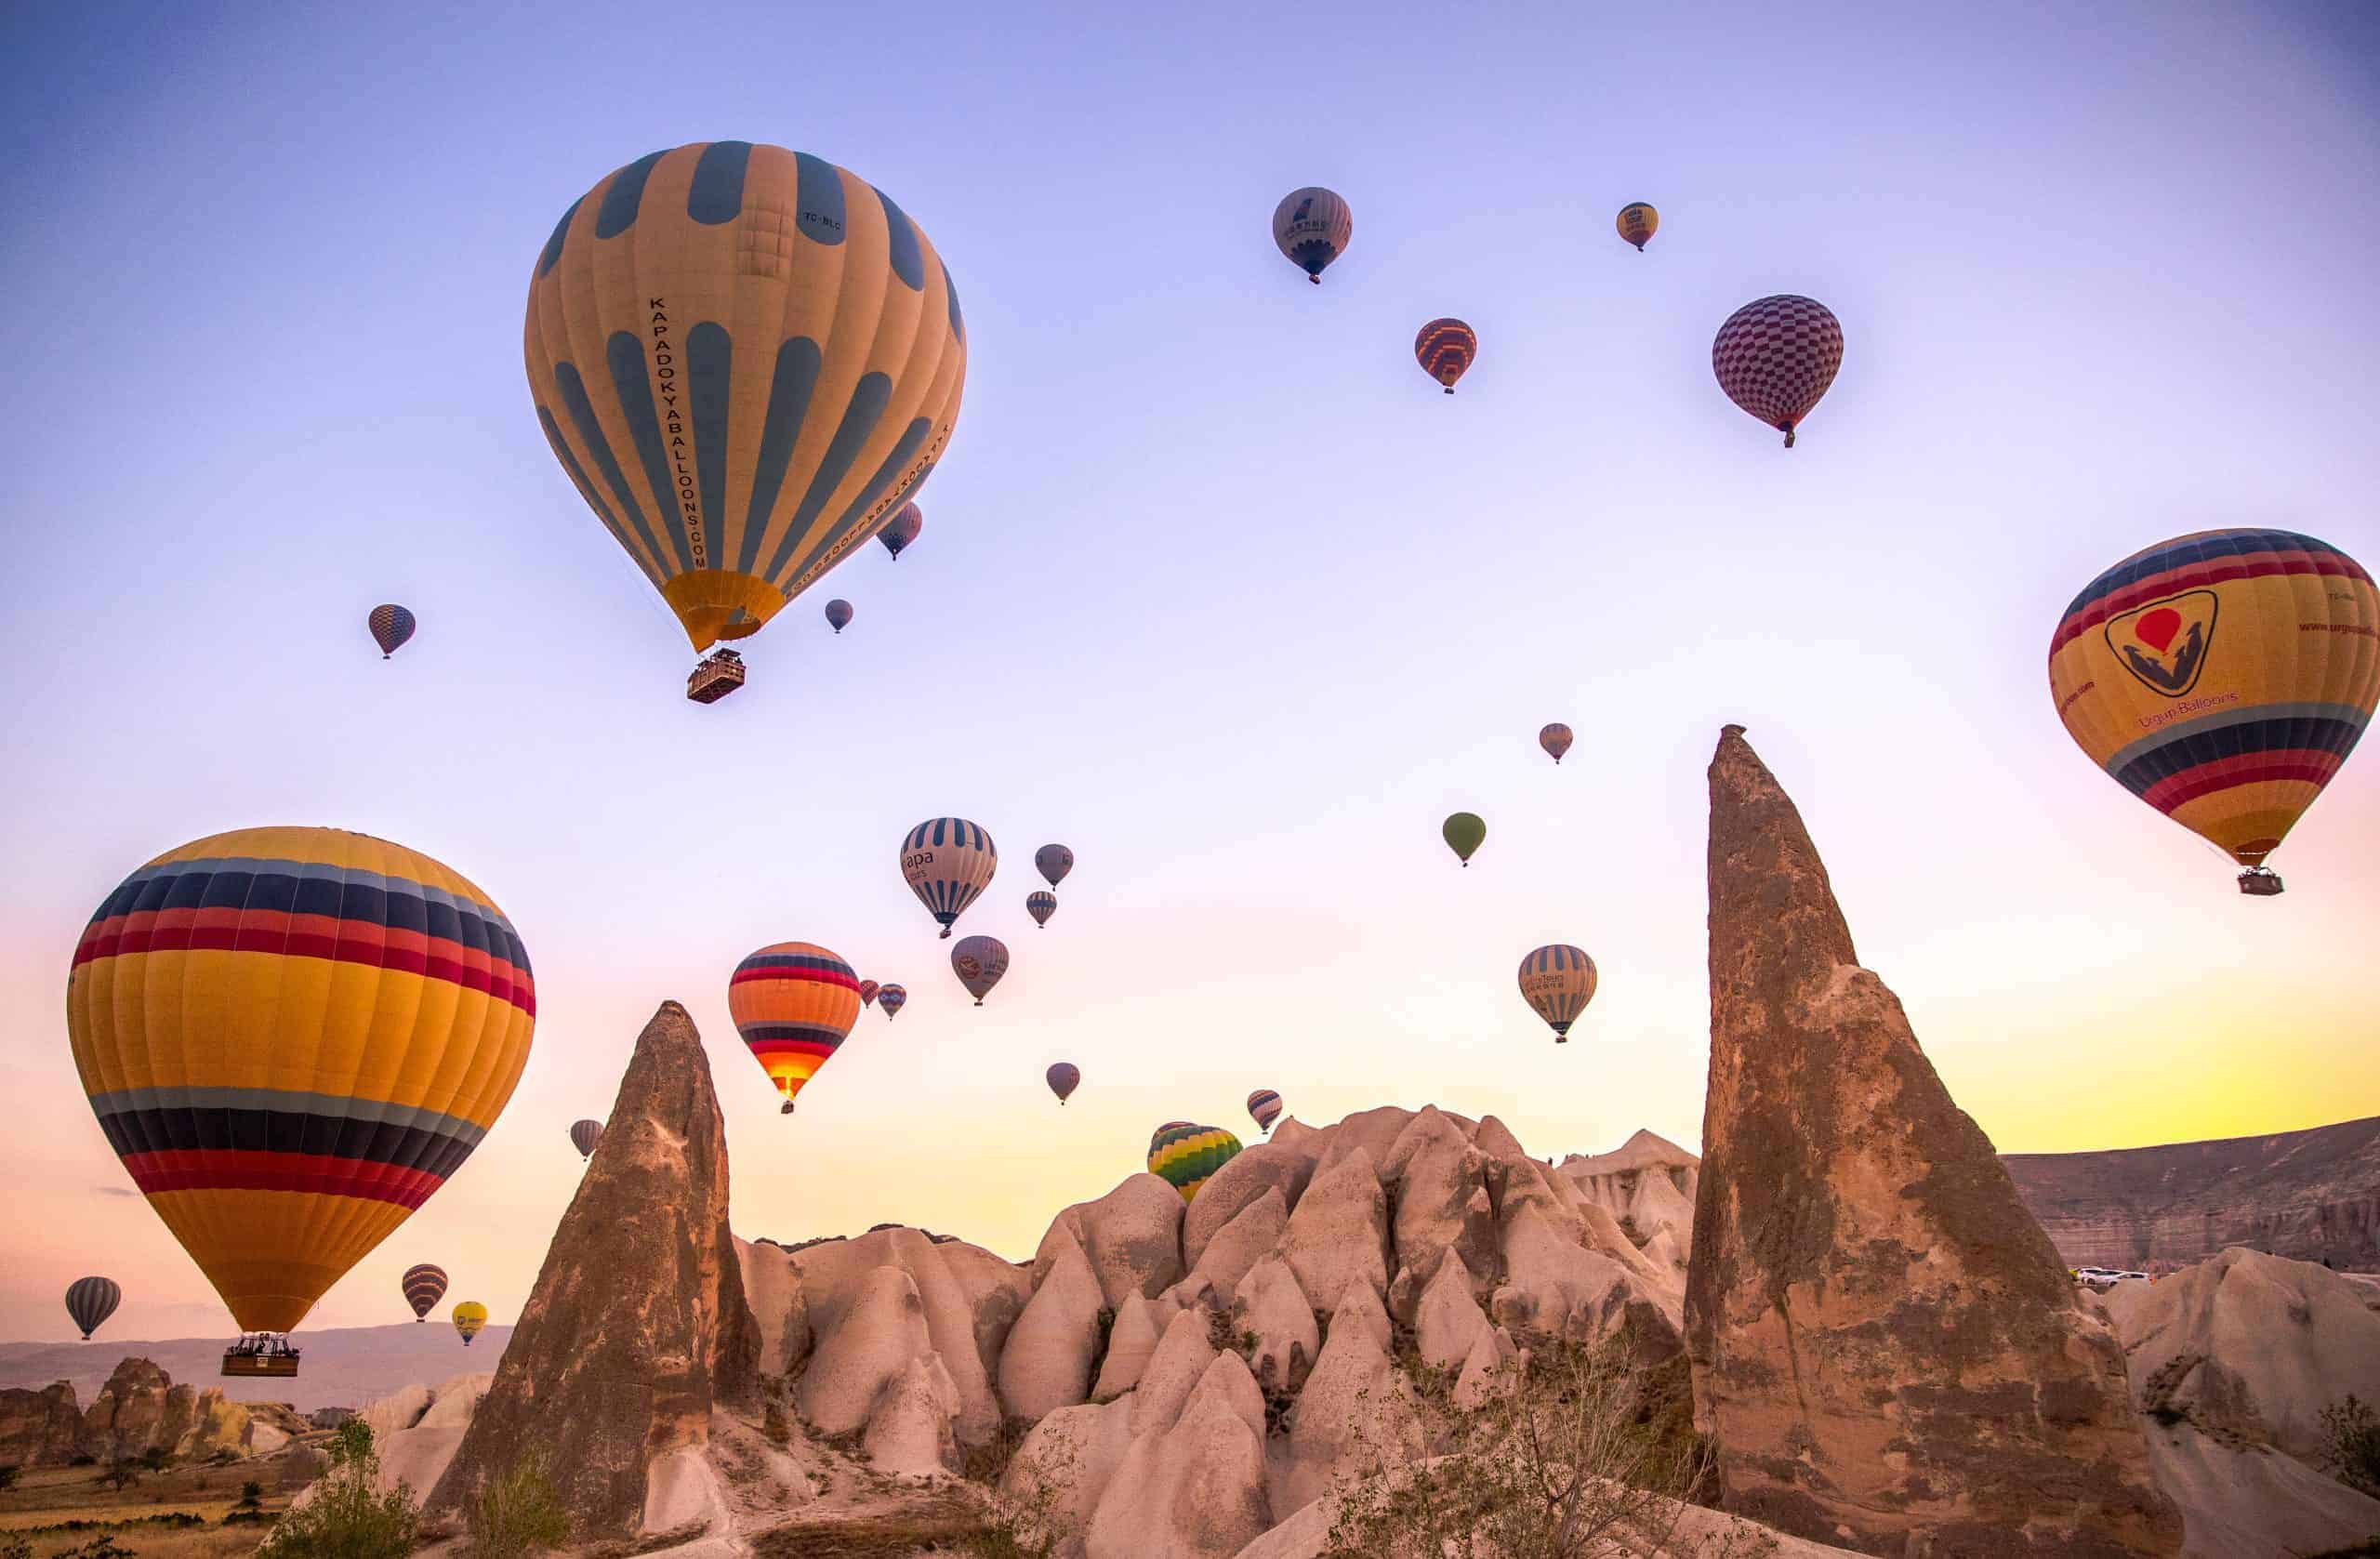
[{"left": 1685, "top": 726, "right": 2183, "bottom": 1559}]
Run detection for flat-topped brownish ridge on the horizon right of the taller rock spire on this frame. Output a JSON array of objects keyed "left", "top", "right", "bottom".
[{"left": 2002, "top": 1116, "right": 2380, "bottom": 1271}]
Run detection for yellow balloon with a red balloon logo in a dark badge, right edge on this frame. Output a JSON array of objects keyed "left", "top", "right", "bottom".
[{"left": 2049, "top": 528, "right": 2380, "bottom": 897}]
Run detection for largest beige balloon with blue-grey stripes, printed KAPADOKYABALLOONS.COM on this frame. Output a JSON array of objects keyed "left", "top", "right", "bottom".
[{"left": 523, "top": 140, "right": 966, "bottom": 699}]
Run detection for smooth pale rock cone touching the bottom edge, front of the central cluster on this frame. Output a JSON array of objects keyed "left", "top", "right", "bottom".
[{"left": 1083, "top": 1354, "right": 1271, "bottom": 1559}]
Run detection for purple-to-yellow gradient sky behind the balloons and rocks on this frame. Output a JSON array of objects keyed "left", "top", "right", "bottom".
[{"left": 0, "top": 0, "right": 2380, "bottom": 1338}]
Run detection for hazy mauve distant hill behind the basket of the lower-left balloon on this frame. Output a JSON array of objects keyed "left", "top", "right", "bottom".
[{"left": 0, "top": 1324, "right": 511, "bottom": 1414}]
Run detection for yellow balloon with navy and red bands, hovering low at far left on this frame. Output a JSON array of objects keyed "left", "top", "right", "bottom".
[{"left": 67, "top": 828, "right": 538, "bottom": 1373}]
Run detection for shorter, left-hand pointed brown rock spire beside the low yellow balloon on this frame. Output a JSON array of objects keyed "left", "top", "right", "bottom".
[{"left": 429, "top": 1002, "right": 760, "bottom": 1540}]
